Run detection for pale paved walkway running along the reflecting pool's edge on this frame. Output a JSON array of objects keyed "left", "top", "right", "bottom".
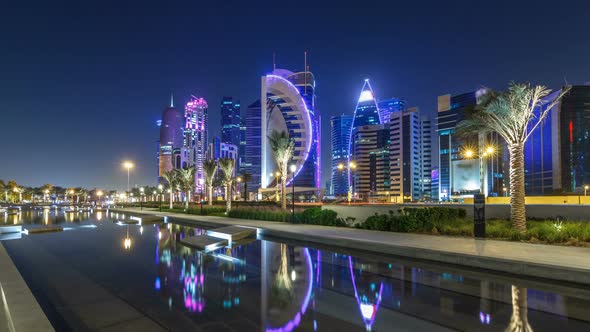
[{"left": 117, "top": 208, "right": 590, "bottom": 285}]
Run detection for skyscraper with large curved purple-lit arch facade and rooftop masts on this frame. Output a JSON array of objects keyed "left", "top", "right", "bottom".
[{"left": 262, "top": 69, "right": 321, "bottom": 191}]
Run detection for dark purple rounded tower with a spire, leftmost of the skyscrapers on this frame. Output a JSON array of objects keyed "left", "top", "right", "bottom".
[{"left": 158, "top": 95, "right": 184, "bottom": 178}]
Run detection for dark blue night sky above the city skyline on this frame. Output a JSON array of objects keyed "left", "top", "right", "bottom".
[{"left": 0, "top": 0, "right": 590, "bottom": 189}]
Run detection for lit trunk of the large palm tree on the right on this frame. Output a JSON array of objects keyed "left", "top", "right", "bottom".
[{"left": 508, "top": 144, "right": 526, "bottom": 233}]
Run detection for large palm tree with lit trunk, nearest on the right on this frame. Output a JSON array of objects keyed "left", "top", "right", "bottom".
[{"left": 458, "top": 83, "right": 570, "bottom": 233}]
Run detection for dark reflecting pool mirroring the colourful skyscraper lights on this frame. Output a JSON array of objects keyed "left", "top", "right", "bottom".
[{"left": 0, "top": 209, "right": 590, "bottom": 332}]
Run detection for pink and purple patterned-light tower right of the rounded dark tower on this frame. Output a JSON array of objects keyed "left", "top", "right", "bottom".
[{"left": 182, "top": 96, "right": 212, "bottom": 192}]
